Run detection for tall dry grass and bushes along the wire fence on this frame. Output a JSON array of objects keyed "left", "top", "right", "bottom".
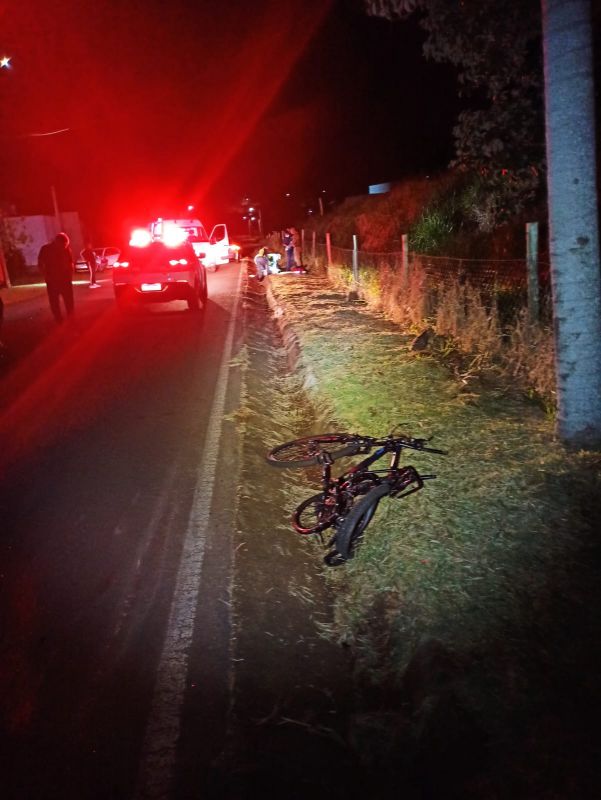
[{"left": 270, "top": 172, "right": 556, "bottom": 406}]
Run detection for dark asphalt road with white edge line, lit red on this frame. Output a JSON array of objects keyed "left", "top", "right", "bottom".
[{"left": 0, "top": 264, "right": 241, "bottom": 800}]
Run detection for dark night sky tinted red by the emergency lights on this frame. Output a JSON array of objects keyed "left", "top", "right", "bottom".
[{"left": 0, "top": 0, "right": 458, "bottom": 241}]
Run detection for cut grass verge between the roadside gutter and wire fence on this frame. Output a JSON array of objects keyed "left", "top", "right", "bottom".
[{"left": 266, "top": 276, "right": 601, "bottom": 797}]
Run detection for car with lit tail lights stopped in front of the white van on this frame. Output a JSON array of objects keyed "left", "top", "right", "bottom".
[{"left": 113, "top": 234, "right": 207, "bottom": 311}]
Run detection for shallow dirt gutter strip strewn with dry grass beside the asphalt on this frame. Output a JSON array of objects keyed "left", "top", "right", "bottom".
[{"left": 214, "top": 280, "right": 357, "bottom": 797}]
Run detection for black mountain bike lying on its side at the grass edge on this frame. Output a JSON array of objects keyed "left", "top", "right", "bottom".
[{"left": 267, "top": 431, "right": 446, "bottom": 567}]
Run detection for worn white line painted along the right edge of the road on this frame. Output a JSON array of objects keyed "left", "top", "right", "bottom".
[{"left": 135, "top": 270, "right": 243, "bottom": 800}]
